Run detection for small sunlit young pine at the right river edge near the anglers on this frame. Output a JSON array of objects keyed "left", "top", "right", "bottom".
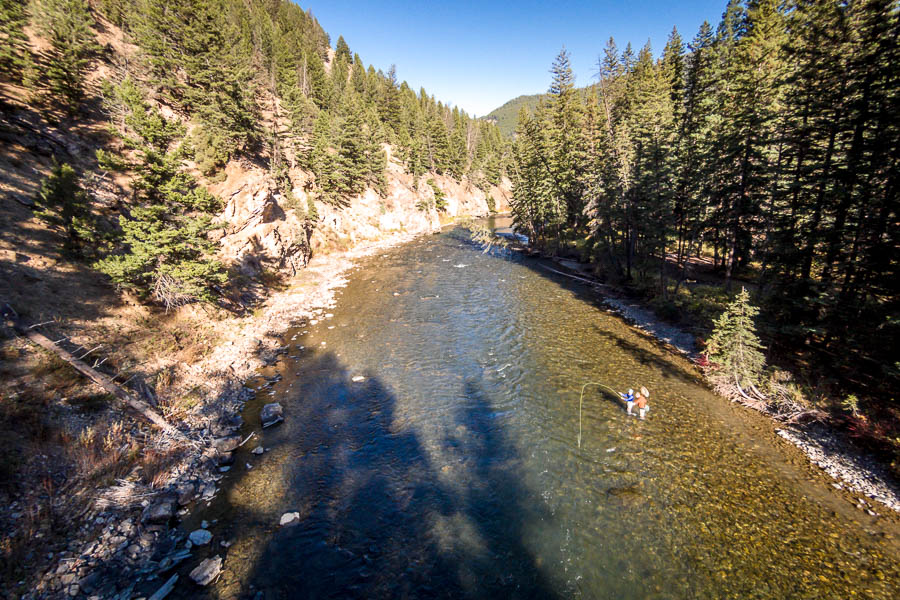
[{"left": 706, "top": 288, "right": 766, "bottom": 389}]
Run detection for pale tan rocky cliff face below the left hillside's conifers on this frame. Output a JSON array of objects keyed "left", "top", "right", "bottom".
[{"left": 210, "top": 155, "right": 510, "bottom": 276}]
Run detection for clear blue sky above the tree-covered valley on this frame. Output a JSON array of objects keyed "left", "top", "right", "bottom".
[{"left": 306, "top": 0, "right": 726, "bottom": 116}]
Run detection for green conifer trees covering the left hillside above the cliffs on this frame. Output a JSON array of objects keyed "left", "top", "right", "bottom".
[{"left": 0, "top": 0, "right": 505, "bottom": 304}]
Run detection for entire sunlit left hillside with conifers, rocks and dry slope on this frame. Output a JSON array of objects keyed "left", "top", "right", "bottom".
[{"left": 0, "top": 0, "right": 509, "bottom": 598}]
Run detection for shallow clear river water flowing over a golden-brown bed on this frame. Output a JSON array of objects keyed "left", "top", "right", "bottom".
[{"left": 179, "top": 220, "right": 900, "bottom": 599}]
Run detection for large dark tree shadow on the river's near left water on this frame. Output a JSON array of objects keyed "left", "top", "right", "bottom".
[{"left": 226, "top": 353, "right": 556, "bottom": 600}]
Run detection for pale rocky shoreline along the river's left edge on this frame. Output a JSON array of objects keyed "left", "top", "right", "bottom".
[{"left": 22, "top": 229, "right": 433, "bottom": 600}]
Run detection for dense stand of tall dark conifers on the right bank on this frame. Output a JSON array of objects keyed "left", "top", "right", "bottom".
[{"left": 512, "top": 0, "right": 900, "bottom": 414}]
